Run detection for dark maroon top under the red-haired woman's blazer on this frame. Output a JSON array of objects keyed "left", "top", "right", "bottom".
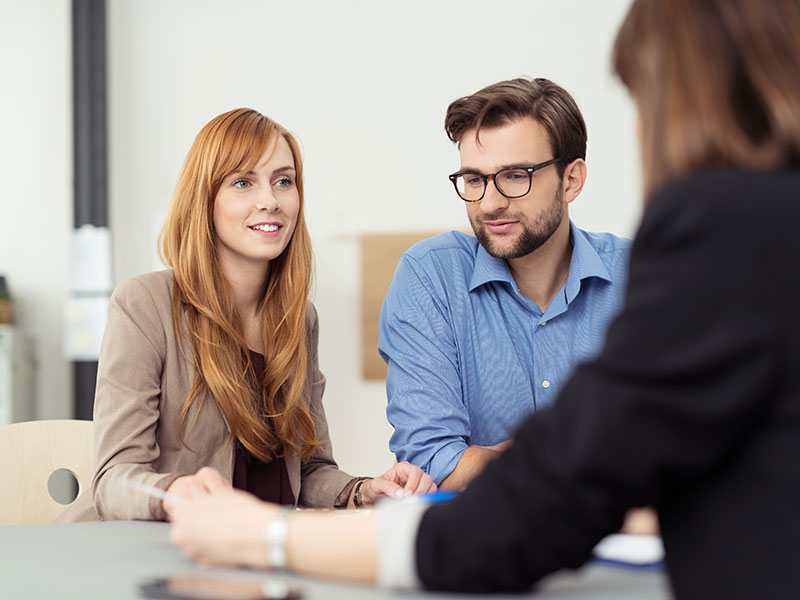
[{"left": 233, "top": 350, "right": 295, "bottom": 505}]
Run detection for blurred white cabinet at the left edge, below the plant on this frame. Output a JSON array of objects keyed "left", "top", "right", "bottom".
[{"left": 0, "top": 325, "right": 34, "bottom": 426}]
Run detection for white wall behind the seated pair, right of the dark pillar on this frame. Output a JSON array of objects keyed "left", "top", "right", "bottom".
[{"left": 109, "top": 0, "right": 639, "bottom": 473}]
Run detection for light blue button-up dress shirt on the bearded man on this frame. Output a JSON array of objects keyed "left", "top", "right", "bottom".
[{"left": 378, "top": 223, "right": 631, "bottom": 484}]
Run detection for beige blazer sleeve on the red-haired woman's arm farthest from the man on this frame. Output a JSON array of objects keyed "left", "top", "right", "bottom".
[{"left": 92, "top": 279, "right": 182, "bottom": 520}]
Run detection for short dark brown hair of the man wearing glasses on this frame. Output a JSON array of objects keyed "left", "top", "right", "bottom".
[{"left": 444, "top": 77, "right": 586, "bottom": 175}]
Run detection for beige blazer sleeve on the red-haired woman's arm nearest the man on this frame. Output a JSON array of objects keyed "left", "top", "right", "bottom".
[{"left": 298, "top": 302, "right": 354, "bottom": 508}]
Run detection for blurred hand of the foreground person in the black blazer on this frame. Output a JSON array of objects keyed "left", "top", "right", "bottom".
[{"left": 167, "top": 487, "right": 278, "bottom": 568}]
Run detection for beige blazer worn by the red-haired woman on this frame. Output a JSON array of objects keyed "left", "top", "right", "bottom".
[{"left": 59, "top": 270, "right": 353, "bottom": 521}]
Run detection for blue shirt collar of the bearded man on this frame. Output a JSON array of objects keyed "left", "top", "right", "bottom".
[{"left": 469, "top": 220, "right": 611, "bottom": 302}]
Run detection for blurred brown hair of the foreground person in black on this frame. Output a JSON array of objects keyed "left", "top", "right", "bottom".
[{"left": 613, "top": 0, "right": 800, "bottom": 198}]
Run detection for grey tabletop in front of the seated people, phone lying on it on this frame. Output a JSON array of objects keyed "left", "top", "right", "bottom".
[{"left": 0, "top": 521, "right": 670, "bottom": 600}]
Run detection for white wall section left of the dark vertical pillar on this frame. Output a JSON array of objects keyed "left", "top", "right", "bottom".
[{"left": 0, "top": 0, "right": 72, "bottom": 418}]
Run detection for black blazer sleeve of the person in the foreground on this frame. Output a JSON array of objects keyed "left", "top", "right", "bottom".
[{"left": 416, "top": 173, "right": 786, "bottom": 592}]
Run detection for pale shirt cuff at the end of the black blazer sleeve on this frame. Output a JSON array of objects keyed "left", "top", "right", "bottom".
[{"left": 377, "top": 498, "right": 431, "bottom": 590}]
